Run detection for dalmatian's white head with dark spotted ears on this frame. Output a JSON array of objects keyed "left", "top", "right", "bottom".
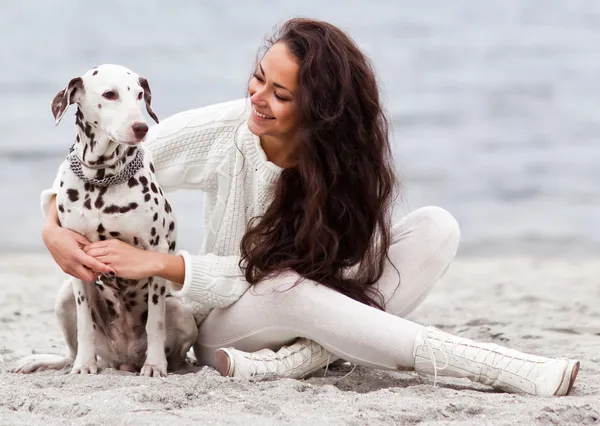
[{"left": 52, "top": 64, "right": 158, "bottom": 145}]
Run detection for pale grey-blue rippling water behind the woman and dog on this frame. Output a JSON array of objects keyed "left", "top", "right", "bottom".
[{"left": 0, "top": 0, "right": 600, "bottom": 255}]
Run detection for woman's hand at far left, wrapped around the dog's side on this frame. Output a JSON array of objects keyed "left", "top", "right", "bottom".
[{"left": 42, "top": 223, "right": 114, "bottom": 282}]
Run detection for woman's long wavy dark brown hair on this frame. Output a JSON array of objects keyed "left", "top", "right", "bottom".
[{"left": 240, "top": 19, "right": 397, "bottom": 309}]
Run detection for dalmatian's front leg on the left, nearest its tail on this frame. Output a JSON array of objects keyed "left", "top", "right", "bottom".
[{"left": 71, "top": 279, "right": 98, "bottom": 374}]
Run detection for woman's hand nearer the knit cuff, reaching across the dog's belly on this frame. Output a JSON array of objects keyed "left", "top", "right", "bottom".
[{"left": 83, "top": 239, "right": 158, "bottom": 280}]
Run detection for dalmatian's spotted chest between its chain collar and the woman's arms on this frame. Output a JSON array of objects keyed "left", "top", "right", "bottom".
[{"left": 56, "top": 161, "right": 176, "bottom": 252}]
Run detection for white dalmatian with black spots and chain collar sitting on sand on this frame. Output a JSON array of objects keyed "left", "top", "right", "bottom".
[{"left": 15, "top": 64, "right": 197, "bottom": 377}]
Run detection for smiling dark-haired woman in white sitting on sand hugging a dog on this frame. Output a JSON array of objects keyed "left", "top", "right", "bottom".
[{"left": 43, "top": 19, "right": 579, "bottom": 396}]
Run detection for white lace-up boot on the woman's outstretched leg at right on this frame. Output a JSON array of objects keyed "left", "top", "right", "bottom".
[{"left": 413, "top": 327, "right": 580, "bottom": 396}]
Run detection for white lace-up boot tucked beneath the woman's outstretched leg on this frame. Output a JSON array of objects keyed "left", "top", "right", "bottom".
[{"left": 215, "top": 339, "right": 338, "bottom": 381}]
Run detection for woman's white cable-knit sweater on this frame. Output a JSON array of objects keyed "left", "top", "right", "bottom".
[{"left": 41, "top": 99, "right": 282, "bottom": 320}]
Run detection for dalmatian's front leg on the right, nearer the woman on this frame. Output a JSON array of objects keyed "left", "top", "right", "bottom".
[{"left": 140, "top": 278, "right": 167, "bottom": 377}]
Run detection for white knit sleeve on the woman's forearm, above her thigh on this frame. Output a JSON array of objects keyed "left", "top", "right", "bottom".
[{"left": 171, "top": 250, "right": 250, "bottom": 308}]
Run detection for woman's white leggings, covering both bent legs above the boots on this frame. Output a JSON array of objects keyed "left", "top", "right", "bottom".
[{"left": 195, "top": 207, "right": 460, "bottom": 369}]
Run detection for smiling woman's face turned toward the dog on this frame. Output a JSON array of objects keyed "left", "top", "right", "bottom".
[{"left": 248, "top": 43, "right": 298, "bottom": 141}]
